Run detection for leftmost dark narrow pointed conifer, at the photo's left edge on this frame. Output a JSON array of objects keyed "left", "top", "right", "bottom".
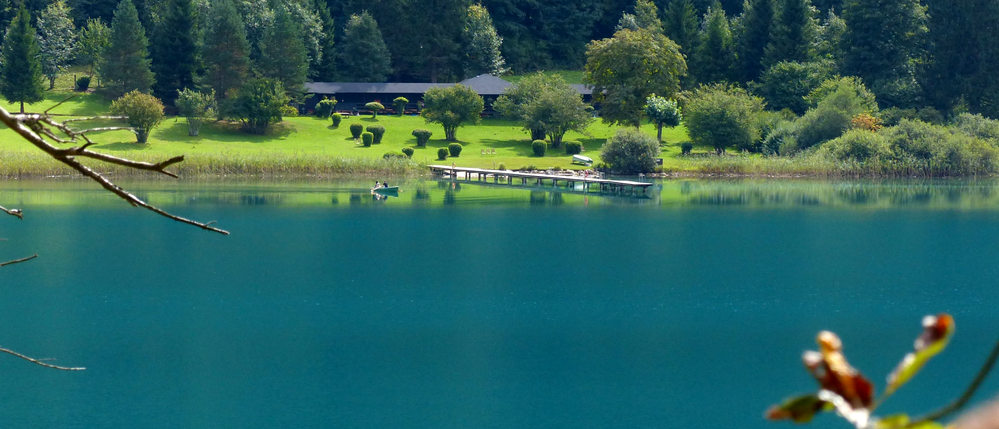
[{"left": 0, "top": 5, "right": 45, "bottom": 113}]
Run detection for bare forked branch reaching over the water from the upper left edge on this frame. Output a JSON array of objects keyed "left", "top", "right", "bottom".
[{"left": 0, "top": 108, "right": 229, "bottom": 235}]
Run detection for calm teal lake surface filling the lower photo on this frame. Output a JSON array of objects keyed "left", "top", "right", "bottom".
[{"left": 0, "top": 180, "right": 999, "bottom": 428}]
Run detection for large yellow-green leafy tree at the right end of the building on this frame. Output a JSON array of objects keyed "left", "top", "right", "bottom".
[{"left": 584, "top": 29, "right": 687, "bottom": 126}]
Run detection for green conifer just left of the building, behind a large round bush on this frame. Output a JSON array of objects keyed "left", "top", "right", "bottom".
[{"left": 258, "top": 6, "right": 309, "bottom": 99}]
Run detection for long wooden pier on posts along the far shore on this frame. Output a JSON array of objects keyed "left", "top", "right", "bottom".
[{"left": 429, "top": 165, "right": 652, "bottom": 194}]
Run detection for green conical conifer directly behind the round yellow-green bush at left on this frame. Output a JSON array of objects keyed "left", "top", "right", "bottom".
[{"left": 99, "top": 0, "right": 153, "bottom": 95}]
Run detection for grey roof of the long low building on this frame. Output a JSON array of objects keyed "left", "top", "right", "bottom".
[{"left": 305, "top": 74, "right": 592, "bottom": 95}]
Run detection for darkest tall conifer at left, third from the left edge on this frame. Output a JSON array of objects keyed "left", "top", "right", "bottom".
[{"left": 150, "top": 0, "right": 197, "bottom": 106}]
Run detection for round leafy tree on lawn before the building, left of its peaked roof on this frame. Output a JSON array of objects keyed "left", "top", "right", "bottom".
[{"left": 420, "top": 84, "right": 485, "bottom": 142}]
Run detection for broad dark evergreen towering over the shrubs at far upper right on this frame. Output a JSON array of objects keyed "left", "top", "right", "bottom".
[{"left": 843, "top": 0, "right": 926, "bottom": 107}]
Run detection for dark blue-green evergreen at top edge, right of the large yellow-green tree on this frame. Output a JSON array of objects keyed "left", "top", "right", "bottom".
[{"left": 763, "top": 0, "right": 815, "bottom": 67}]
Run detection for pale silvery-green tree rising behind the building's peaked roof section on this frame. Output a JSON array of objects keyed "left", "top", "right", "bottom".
[{"left": 464, "top": 4, "right": 506, "bottom": 76}]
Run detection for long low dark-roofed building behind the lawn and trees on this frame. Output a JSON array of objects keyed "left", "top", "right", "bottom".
[{"left": 305, "top": 74, "right": 592, "bottom": 112}]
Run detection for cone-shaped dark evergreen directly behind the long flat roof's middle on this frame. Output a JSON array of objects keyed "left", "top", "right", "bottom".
[{"left": 337, "top": 11, "right": 392, "bottom": 82}]
